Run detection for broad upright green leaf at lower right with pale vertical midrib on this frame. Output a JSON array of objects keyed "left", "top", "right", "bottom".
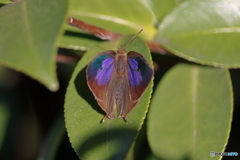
[{"left": 148, "top": 64, "right": 233, "bottom": 159}]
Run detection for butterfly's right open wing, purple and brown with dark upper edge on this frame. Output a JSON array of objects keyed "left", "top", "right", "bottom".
[{"left": 118, "top": 51, "right": 153, "bottom": 118}]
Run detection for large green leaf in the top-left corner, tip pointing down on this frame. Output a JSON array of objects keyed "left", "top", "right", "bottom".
[{"left": 0, "top": 0, "right": 68, "bottom": 90}]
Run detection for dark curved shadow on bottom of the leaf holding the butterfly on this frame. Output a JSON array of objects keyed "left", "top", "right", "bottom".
[{"left": 75, "top": 126, "right": 137, "bottom": 160}]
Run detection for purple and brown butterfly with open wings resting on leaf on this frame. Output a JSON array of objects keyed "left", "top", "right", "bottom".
[{"left": 86, "top": 30, "right": 153, "bottom": 122}]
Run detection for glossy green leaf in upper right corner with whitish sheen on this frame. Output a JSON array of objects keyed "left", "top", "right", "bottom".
[{"left": 155, "top": 0, "right": 240, "bottom": 68}]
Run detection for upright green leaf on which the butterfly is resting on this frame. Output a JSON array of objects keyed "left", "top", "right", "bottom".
[{"left": 65, "top": 36, "right": 153, "bottom": 160}]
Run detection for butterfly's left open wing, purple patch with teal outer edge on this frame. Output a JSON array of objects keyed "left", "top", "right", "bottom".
[{"left": 86, "top": 50, "right": 116, "bottom": 118}]
